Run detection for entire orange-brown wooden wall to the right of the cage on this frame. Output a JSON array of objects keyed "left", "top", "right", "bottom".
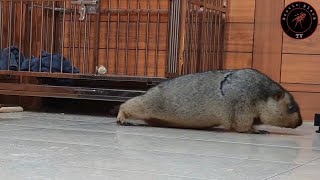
[{"left": 230, "top": 0, "right": 320, "bottom": 120}]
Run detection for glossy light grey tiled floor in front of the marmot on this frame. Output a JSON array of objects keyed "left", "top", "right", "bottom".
[{"left": 0, "top": 112, "right": 320, "bottom": 180}]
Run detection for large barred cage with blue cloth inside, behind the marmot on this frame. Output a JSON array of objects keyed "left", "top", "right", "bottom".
[{"left": 0, "top": 0, "right": 227, "bottom": 101}]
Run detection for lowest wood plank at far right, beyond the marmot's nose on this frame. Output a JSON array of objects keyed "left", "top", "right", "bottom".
[{"left": 292, "top": 92, "right": 320, "bottom": 121}]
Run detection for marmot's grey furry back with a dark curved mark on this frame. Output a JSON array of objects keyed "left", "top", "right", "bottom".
[{"left": 152, "top": 69, "right": 283, "bottom": 114}]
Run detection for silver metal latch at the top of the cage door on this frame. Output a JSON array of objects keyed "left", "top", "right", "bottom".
[{"left": 71, "top": 0, "right": 99, "bottom": 21}]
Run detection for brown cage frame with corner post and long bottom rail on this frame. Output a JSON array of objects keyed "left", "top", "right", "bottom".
[{"left": 0, "top": 0, "right": 228, "bottom": 101}]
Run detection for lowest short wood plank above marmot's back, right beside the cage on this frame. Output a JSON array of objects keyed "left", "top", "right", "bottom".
[{"left": 223, "top": 52, "right": 252, "bottom": 69}]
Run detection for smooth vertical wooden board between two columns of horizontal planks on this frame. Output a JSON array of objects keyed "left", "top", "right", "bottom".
[{"left": 253, "top": 0, "right": 284, "bottom": 82}]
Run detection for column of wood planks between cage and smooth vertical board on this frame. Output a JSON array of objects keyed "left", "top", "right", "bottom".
[{"left": 224, "top": 0, "right": 255, "bottom": 69}]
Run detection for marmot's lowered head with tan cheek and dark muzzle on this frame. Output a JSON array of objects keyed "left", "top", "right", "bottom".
[{"left": 259, "top": 91, "right": 302, "bottom": 128}]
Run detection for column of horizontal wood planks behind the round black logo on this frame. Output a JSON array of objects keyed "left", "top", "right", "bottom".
[{"left": 281, "top": 0, "right": 320, "bottom": 121}]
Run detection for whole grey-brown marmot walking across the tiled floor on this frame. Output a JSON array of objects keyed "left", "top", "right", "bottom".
[{"left": 117, "top": 69, "right": 302, "bottom": 133}]
